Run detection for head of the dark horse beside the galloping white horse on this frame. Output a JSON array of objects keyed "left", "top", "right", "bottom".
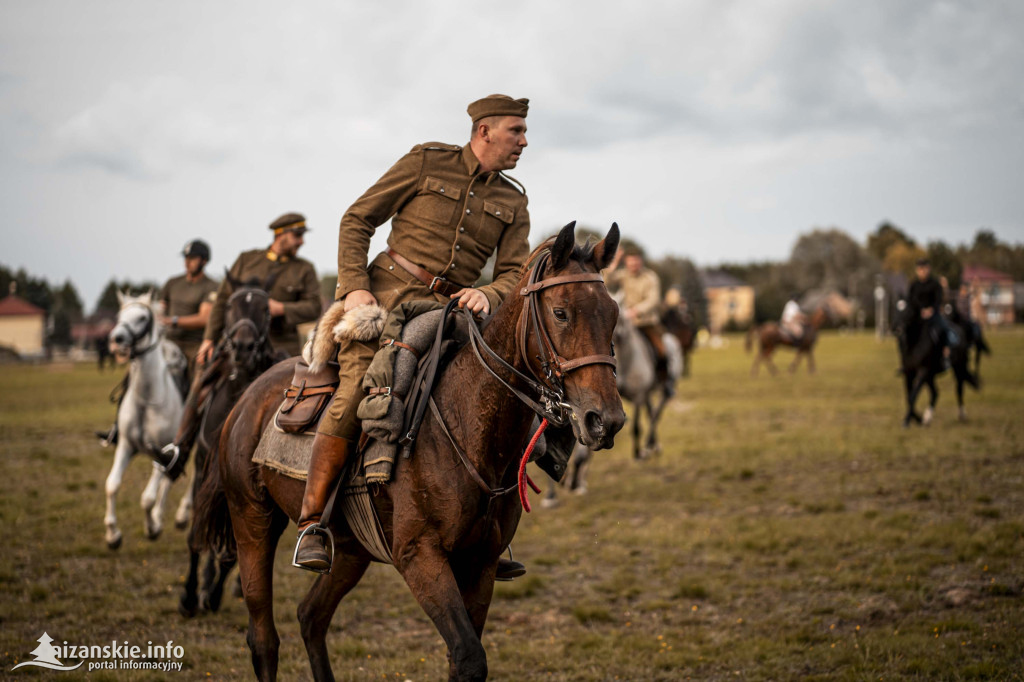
[{"left": 224, "top": 273, "right": 275, "bottom": 370}]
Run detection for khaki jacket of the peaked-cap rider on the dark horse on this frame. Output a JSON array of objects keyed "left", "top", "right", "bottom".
[{"left": 203, "top": 249, "right": 322, "bottom": 355}]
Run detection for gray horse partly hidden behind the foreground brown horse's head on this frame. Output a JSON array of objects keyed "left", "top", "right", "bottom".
[{"left": 542, "top": 303, "right": 683, "bottom": 507}]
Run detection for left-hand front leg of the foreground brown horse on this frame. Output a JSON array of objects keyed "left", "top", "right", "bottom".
[{"left": 394, "top": 540, "right": 494, "bottom": 682}]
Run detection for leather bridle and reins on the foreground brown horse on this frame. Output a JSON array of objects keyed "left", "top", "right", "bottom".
[{"left": 467, "top": 253, "right": 616, "bottom": 427}]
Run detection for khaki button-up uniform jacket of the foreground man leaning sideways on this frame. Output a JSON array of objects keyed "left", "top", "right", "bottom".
[{"left": 335, "top": 142, "right": 529, "bottom": 311}]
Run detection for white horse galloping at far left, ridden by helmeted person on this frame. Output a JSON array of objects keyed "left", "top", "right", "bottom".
[{"left": 103, "top": 292, "right": 191, "bottom": 550}]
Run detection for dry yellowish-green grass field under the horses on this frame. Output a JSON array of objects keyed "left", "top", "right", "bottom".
[{"left": 0, "top": 329, "right": 1024, "bottom": 682}]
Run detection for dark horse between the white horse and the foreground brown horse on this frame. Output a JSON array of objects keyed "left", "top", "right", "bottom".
[{"left": 163, "top": 273, "right": 286, "bottom": 617}]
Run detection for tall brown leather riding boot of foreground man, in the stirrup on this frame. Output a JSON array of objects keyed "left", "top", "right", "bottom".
[{"left": 295, "top": 432, "right": 355, "bottom": 572}]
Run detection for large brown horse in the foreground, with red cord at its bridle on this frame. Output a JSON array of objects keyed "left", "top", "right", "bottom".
[{"left": 197, "top": 223, "right": 626, "bottom": 680}]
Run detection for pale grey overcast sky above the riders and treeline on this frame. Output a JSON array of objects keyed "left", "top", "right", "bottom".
[{"left": 0, "top": 0, "right": 1024, "bottom": 309}]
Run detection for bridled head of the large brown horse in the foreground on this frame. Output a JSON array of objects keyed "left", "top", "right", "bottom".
[{"left": 513, "top": 222, "right": 626, "bottom": 450}]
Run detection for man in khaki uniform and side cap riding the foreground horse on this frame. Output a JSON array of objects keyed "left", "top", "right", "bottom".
[{"left": 295, "top": 94, "right": 529, "bottom": 578}]
